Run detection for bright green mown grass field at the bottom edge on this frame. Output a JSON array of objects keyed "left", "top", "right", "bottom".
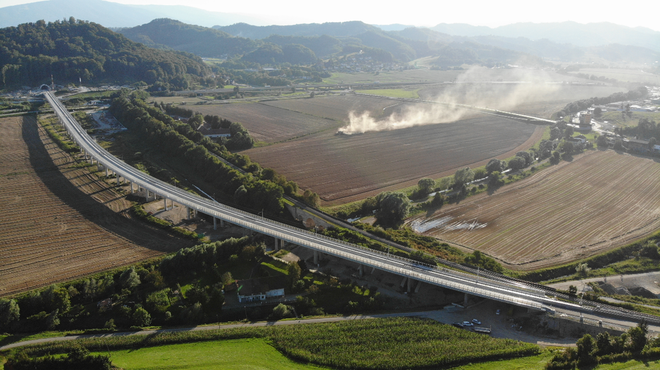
[{"left": 94, "top": 338, "right": 324, "bottom": 370}]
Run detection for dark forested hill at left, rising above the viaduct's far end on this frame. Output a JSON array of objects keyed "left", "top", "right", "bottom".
[{"left": 0, "top": 18, "right": 211, "bottom": 89}]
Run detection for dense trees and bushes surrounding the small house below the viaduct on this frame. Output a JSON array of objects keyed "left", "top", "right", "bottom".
[{"left": 0, "top": 237, "right": 386, "bottom": 343}]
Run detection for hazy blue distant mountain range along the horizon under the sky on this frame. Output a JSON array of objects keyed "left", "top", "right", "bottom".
[{"left": 0, "top": 0, "right": 660, "bottom": 66}]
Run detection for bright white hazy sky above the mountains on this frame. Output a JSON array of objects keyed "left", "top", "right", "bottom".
[{"left": 0, "top": 0, "right": 660, "bottom": 31}]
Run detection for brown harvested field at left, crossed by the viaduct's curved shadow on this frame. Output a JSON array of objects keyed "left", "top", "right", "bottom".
[{"left": 0, "top": 117, "right": 190, "bottom": 296}]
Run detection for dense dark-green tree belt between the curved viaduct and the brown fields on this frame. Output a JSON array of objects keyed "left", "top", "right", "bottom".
[{"left": 110, "top": 95, "right": 318, "bottom": 216}]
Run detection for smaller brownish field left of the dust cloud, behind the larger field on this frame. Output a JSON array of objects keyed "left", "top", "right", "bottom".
[{"left": 191, "top": 99, "right": 340, "bottom": 143}]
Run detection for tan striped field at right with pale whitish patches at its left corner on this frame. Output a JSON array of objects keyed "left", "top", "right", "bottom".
[{"left": 412, "top": 150, "right": 660, "bottom": 270}]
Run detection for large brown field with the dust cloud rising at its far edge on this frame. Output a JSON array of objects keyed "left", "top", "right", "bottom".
[{"left": 246, "top": 115, "right": 545, "bottom": 205}]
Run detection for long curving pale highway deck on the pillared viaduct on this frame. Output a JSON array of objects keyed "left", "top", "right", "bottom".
[{"left": 44, "top": 92, "right": 660, "bottom": 322}]
